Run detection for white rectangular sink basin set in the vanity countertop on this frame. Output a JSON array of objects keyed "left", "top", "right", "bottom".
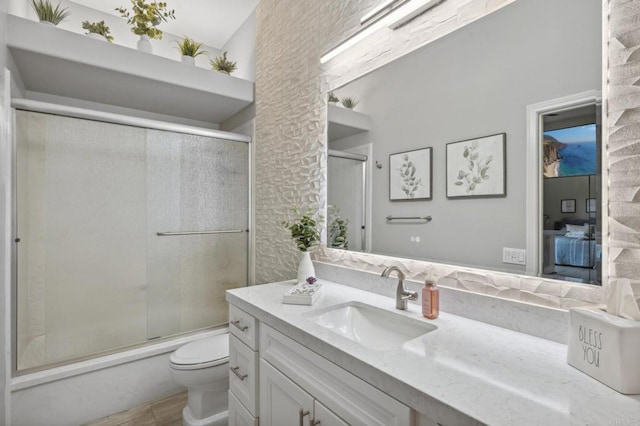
[{"left": 303, "top": 302, "right": 437, "bottom": 351}]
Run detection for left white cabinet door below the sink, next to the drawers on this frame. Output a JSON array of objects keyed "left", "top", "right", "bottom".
[{"left": 260, "top": 360, "right": 313, "bottom": 426}]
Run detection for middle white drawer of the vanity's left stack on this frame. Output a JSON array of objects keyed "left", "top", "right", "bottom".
[{"left": 229, "top": 335, "right": 258, "bottom": 416}]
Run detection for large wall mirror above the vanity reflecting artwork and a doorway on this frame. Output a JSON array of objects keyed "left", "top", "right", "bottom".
[{"left": 327, "top": 0, "right": 602, "bottom": 285}]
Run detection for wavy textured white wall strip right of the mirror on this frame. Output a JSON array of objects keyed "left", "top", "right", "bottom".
[{"left": 607, "top": 0, "right": 640, "bottom": 295}]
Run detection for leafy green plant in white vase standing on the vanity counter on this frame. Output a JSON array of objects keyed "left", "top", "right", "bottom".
[{"left": 282, "top": 207, "right": 324, "bottom": 283}]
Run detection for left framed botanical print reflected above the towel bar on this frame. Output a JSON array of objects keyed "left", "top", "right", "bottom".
[{"left": 389, "top": 148, "right": 433, "bottom": 201}]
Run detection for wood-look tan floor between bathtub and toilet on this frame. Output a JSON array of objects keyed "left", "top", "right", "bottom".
[{"left": 85, "top": 392, "right": 187, "bottom": 426}]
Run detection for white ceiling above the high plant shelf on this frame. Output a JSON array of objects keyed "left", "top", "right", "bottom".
[{"left": 72, "top": 0, "right": 258, "bottom": 49}]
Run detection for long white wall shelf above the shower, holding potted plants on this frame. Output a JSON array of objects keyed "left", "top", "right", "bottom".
[{"left": 7, "top": 15, "right": 253, "bottom": 123}]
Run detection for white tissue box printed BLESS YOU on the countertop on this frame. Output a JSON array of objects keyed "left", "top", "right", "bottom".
[{"left": 567, "top": 307, "right": 640, "bottom": 394}]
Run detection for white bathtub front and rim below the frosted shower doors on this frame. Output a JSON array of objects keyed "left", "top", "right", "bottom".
[{"left": 11, "top": 328, "right": 228, "bottom": 426}]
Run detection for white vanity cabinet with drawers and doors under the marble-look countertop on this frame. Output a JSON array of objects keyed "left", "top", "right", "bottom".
[{"left": 229, "top": 305, "right": 415, "bottom": 426}]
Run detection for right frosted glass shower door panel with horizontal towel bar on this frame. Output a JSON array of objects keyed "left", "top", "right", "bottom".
[{"left": 147, "top": 131, "right": 249, "bottom": 337}]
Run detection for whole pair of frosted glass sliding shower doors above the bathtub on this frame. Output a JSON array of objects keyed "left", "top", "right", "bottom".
[{"left": 14, "top": 106, "right": 250, "bottom": 373}]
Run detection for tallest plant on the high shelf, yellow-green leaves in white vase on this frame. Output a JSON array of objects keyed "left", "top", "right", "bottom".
[{"left": 116, "top": 0, "right": 176, "bottom": 53}]
